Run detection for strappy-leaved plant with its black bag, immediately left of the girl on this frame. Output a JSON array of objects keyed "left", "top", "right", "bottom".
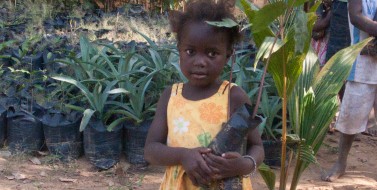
[{"left": 114, "top": 29, "right": 179, "bottom": 169}]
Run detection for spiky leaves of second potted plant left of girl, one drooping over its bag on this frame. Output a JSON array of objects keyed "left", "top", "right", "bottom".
[{"left": 52, "top": 37, "right": 128, "bottom": 131}]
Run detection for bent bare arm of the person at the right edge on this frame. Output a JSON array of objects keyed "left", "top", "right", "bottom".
[{"left": 348, "top": 0, "right": 377, "bottom": 36}]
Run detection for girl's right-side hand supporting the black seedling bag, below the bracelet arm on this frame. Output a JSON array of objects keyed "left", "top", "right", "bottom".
[{"left": 203, "top": 152, "right": 249, "bottom": 180}]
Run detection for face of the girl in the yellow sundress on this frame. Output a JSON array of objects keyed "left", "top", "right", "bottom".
[{"left": 178, "top": 22, "right": 231, "bottom": 86}]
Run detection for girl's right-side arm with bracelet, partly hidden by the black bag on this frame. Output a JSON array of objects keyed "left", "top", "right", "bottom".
[{"left": 204, "top": 86, "right": 264, "bottom": 179}]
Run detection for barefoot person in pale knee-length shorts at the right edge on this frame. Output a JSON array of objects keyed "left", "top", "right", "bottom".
[{"left": 322, "top": 0, "right": 377, "bottom": 181}]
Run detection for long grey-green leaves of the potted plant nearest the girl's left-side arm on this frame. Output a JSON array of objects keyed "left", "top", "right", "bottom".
[{"left": 97, "top": 40, "right": 162, "bottom": 124}]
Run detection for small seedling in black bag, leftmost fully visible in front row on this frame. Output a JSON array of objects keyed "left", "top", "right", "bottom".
[{"left": 3, "top": 46, "right": 46, "bottom": 153}]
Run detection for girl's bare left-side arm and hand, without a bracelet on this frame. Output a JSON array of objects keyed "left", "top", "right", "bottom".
[{"left": 144, "top": 88, "right": 211, "bottom": 185}]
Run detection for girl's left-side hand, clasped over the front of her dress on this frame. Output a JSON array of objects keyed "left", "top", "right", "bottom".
[{"left": 181, "top": 148, "right": 212, "bottom": 186}]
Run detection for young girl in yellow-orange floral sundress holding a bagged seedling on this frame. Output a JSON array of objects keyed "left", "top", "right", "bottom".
[{"left": 144, "top": 0, "right": 264, "bottom": 190}]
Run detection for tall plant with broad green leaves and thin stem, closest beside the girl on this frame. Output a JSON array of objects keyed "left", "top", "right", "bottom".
[{"left": 241, "top": 0, "right": 315, "bottom": 189}]
